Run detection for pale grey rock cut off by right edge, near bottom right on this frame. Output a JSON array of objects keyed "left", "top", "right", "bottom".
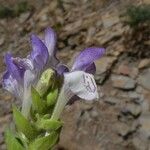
[{"left": 139, "top": 112, "right": 150, "bottom": 138}]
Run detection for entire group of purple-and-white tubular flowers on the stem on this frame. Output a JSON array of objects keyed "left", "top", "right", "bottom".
[{"left": 3, "top": 28, "right": 105, "bottom": 119}]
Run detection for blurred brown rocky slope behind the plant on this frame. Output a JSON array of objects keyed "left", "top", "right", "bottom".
[{"left": 0, "top": 0, "right": 150, "bottom": 150}]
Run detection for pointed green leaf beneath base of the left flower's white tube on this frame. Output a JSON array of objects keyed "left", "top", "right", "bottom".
[{"left": 13, "top": 106, "right": 37, "bottom": 140}]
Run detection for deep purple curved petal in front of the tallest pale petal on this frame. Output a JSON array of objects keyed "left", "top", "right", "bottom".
[{"left": 30, "top": 35, "right": 49, "bottom": 69}]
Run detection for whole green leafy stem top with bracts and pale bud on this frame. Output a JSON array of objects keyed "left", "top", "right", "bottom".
[{"left": 5, "top": 69, "right": 62, "bottom": 150}]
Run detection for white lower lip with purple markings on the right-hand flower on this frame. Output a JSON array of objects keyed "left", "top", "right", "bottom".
[{"left": 64, "top": 71, "right": 98, "bottom": 100}]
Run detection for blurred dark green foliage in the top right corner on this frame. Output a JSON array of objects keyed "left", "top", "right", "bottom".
[{"left": 126, "top": 5, "right": 150, "bottom": 27}]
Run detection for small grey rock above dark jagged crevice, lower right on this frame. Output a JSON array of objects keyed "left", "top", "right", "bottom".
[{"left": 122, "top": 103, "right": 142, "bottom": 118}]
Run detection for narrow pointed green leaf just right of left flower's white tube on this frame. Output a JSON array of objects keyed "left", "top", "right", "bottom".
[{"left": 31, "top": 87, "right": 46, "bottom": 114}]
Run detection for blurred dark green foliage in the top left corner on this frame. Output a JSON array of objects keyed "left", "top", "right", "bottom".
[{"left": 0, "top": 1, "right": 32, "bottom": 18}]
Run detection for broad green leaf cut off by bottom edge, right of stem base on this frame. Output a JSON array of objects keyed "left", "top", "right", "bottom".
[{"left": 29, "top": 132, "right": 58, "bottom": 150}]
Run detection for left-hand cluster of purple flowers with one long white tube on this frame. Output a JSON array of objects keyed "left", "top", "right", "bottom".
[{"left": 2, "top": 28, "right": 58, "bottom": 117}]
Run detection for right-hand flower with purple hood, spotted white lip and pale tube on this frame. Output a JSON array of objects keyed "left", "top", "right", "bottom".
[{"left": 51, "top": 47, "right": 105, "bottom": 120}]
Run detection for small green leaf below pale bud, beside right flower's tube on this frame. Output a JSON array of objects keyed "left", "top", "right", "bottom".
[{"left": 47, "top": 88, "right": 58, "bottom": 106}]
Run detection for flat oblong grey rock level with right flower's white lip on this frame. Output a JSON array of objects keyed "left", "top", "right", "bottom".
[{"left": 111, "top": 75, "right": 136, "bottom": 90}]
